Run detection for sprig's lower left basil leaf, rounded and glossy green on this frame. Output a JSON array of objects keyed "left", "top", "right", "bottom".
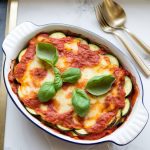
[{"left": 38, "top": 82, "right": 56, "bottom": 102}]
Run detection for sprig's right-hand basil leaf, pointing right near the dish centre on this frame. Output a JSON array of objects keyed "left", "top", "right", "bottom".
[{"left": 62, "top": 68, "right": 81, "bottom": 83}]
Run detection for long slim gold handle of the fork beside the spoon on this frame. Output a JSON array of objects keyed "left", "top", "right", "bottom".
[{"left": 113, "top": 32, "right": 150, "bottom": 76}]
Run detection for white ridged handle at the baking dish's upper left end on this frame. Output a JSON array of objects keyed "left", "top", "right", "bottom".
[{"left": 2, "top": 22, "right": 40, "bottom": 60}]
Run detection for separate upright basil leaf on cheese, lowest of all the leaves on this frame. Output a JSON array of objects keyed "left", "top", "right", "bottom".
[{"left": 72, "top": 89, "right": 90, "bottom": 117}]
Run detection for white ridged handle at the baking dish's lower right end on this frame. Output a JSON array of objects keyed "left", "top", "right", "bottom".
[{"left": 110, "top": 101, "right": 149, "bottom": 145}]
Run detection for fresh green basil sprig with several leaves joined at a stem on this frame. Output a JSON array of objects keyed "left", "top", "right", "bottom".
[{"left": 36, "top": 43, "right": 81, "bottom": 102}]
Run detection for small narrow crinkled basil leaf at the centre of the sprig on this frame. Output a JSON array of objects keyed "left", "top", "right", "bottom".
[{"left": 53, "top": 67, "right": 63, "bottom": 90}]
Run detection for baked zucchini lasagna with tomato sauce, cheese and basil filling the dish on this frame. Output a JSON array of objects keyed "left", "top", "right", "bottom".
[{"left": 8, "top": 32, "right": 138, "bottom": 140}]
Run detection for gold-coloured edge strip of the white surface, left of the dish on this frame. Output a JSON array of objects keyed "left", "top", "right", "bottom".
[{"left": 0, "top": 0, "right": 18, "bottom": 150}]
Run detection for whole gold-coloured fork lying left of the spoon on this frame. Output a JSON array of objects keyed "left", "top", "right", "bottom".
[{"left": 95, "top": 4, "right": 150, "bottom": 76}]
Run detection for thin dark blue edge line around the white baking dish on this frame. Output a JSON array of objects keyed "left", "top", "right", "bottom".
[{"left": 2, "top": 21, "right": 149, "bottom": 146}]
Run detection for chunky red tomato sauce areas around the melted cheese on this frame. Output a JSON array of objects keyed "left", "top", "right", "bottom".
[{"left": 8, "top": 33, "right": 138, "bottom": 140}]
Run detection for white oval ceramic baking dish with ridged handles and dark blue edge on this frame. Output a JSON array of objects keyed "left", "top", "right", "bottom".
[{"left": 2, "top": 22, "right": 148, "bottom": 145}]
